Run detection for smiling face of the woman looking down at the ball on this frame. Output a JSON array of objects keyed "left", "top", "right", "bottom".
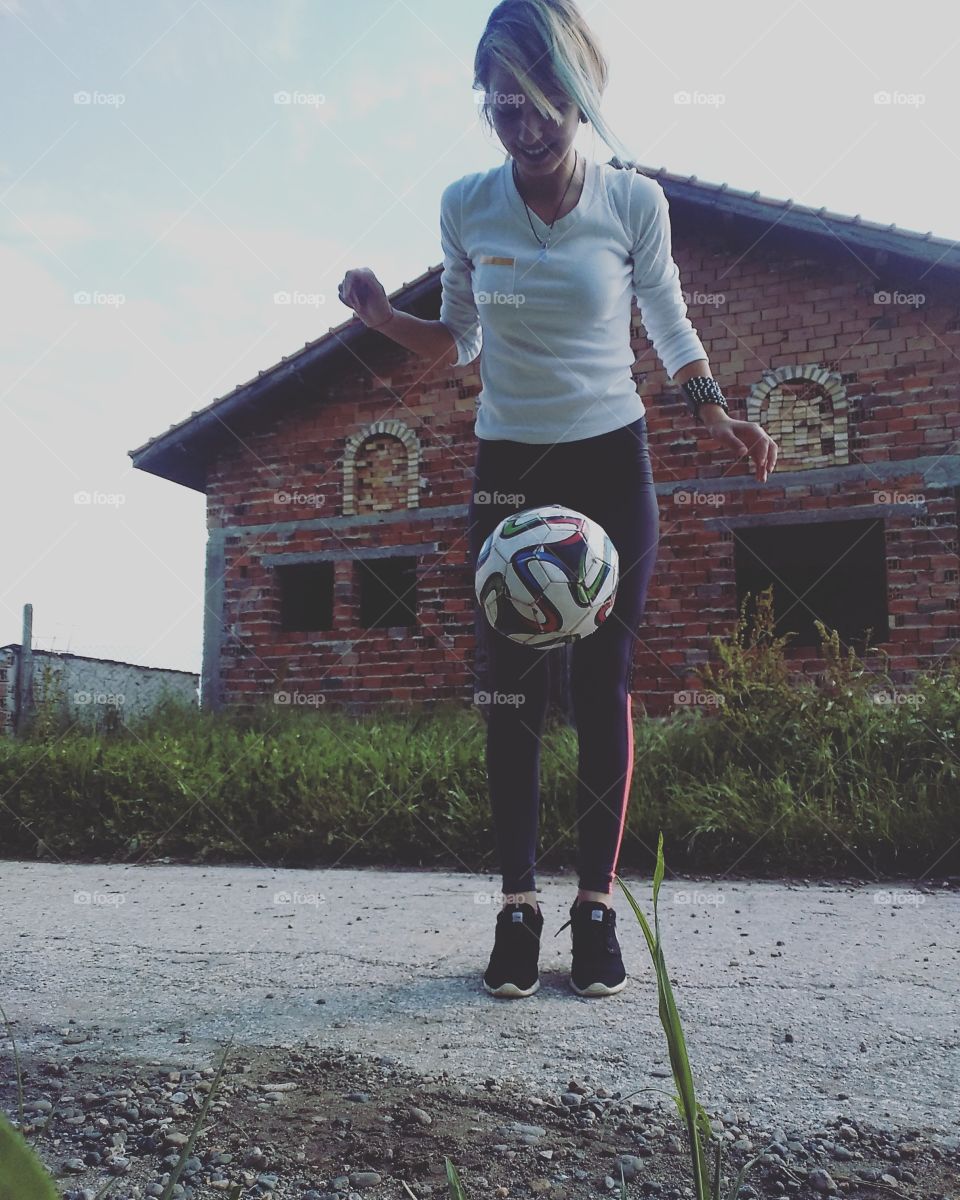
[{"left": 488, "top": 66, "right": 580, "bottom": 179}]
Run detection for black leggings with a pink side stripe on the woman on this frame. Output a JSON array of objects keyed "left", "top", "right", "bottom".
[{"left": 469, "top": 416, "right": 660, "bottom": 894}]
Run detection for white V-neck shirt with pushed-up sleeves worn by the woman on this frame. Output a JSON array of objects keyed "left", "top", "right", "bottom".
[{"left": 440, "top": 158, "right": 707, "bottom": 443}]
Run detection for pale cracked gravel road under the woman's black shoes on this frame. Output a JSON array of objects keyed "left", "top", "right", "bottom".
[{"left": 0, "top": 860, "right": 960, "bottom": 1142}]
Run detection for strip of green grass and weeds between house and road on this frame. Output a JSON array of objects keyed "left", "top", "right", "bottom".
[{"left": 0, "top": 588, "right": 960, "bottom": 877}]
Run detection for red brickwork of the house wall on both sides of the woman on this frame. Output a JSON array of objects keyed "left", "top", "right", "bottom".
[{"left": 208, "top": 235, "right": 960, "bottom": 714}]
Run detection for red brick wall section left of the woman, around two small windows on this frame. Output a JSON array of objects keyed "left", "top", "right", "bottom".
[{"left": 208, "top": 350, "right": 480, "bottom": 707}]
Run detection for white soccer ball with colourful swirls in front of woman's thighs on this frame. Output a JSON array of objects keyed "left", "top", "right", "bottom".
[{"left": 474, "top": 504, "right": 619, "bottom": 649}]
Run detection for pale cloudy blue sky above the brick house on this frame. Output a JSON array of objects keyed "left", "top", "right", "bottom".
[{"left": 0, "top": 0, "right": 960, "bottom": 672}]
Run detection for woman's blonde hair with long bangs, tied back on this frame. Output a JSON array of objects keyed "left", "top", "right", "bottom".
[{"left": 474, "top": 0, "right": 634, "bottom": 160}]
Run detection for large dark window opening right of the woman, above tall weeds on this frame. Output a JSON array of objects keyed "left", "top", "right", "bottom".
[{"left": 733, "top": 520, "right": 890, "bottom": 655}]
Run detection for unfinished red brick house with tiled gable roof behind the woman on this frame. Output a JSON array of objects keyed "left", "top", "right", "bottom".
[{"left": 130, "top": 169, "right": 960, "bottom": 715}]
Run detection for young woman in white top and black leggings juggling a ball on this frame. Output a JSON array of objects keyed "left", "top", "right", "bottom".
[{"left": 340, "top": 0, "right": 778, "bottom": 997}]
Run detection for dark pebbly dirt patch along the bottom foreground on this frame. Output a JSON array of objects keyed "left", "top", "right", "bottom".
[{"left": 0, "top": 1045, "right": 960, "bottom": 1200}]
